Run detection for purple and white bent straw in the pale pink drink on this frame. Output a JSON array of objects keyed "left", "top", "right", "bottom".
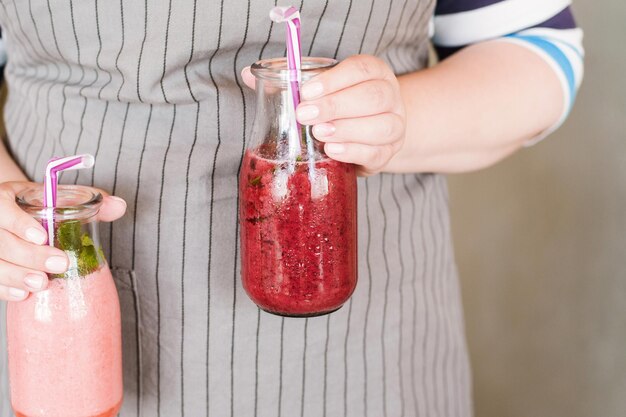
[{"left": 43, "top": 154, "right": 95, "bottom": 246}]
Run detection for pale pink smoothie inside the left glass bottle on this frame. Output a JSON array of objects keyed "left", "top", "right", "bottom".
[{"left": 7, "top": 266, "right": 122, "bottom": 417}]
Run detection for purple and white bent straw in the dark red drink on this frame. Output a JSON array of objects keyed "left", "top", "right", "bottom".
[{"left": 270, "top": 6, "right": 302, "bottom": 159}]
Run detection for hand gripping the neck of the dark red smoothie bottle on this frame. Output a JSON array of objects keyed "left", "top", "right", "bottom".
[{"left": 243, "top": 55, "right": 406, "bottom": 175}]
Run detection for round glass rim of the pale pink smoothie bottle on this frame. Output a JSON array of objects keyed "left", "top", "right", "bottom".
[{"left": 15, "top": 184, "right": 103, "bottom": 221}]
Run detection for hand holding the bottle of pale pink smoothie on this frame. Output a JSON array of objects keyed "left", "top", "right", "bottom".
[{"left": 0, "top": 182, "right": 126, "bottom": 301}]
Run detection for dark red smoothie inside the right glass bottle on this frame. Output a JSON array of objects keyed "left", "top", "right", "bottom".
[{"left": 239, "top": 151, "right": 357, "bottom": 317}]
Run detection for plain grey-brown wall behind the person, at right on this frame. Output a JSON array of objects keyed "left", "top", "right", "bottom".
[{"left": 450, "top": 0, "right": 626, "bottom": 417}]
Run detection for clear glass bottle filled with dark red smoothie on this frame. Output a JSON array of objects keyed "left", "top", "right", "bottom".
[{"left": 239, "top": 58, "right": 357, "bottom": 317}]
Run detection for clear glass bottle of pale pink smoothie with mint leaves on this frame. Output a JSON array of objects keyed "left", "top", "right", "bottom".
[{"left": 7, "top": 186, "right": 123, "bottom": 417}]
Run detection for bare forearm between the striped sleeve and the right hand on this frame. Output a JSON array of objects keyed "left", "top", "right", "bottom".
[{"left": 385, "top": 42, "right": 564, "bottom": 173}]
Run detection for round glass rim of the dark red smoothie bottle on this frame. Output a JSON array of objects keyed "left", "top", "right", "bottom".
[{"left": 251, "top": 56, "right": 337, "bottom": 83}]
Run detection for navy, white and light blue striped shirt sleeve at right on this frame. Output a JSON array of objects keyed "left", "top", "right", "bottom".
[{"left": 433, "top": 0, "right": 584, "bottom": 145}]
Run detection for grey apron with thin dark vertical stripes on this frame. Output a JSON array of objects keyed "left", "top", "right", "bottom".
[{"left": 0, "top": 0, "right": 471, "bottom": 417}]
